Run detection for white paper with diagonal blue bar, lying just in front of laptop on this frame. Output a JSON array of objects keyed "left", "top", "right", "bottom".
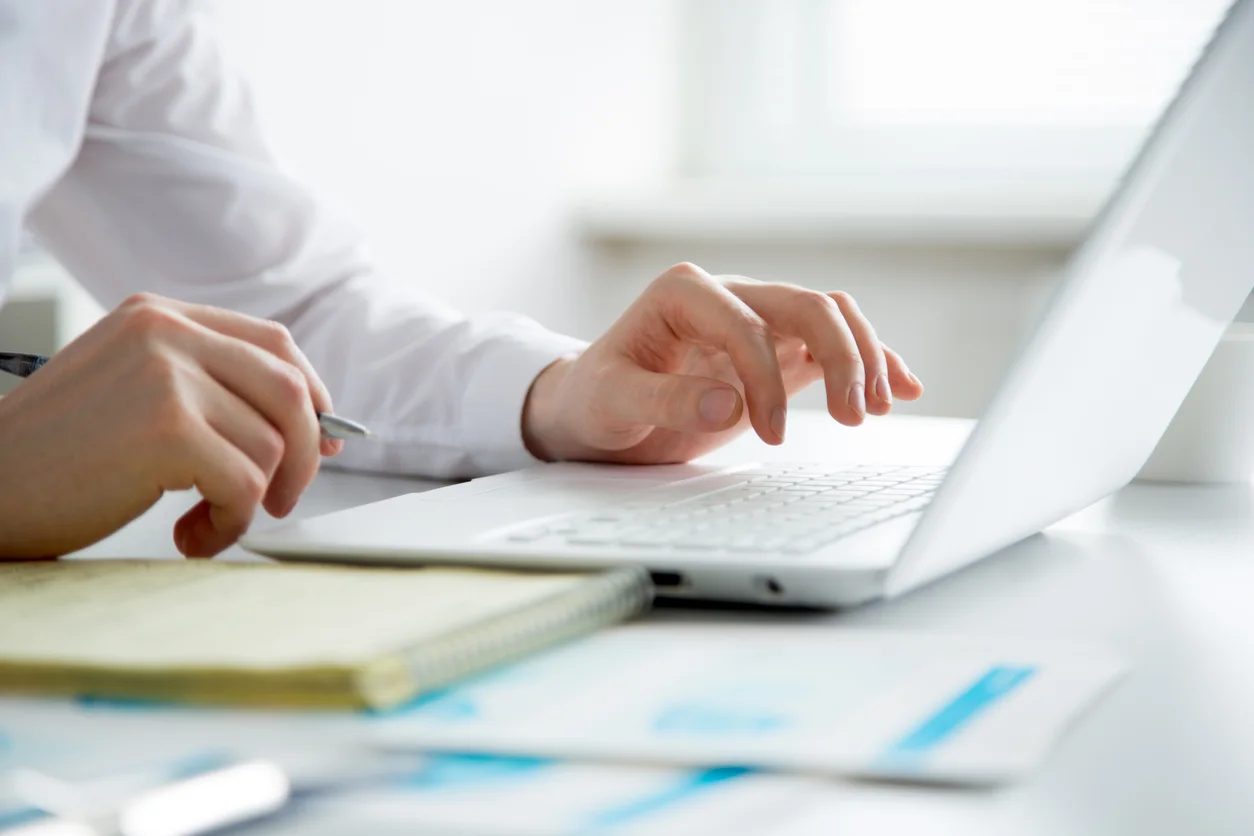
[{"left": 374, "top": 624, "right": 1124, "bottom": 783}]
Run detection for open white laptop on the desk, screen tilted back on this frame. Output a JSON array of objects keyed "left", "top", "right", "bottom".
[{"left": 245, "top": 0, "right": 1254, "bottom": 607}]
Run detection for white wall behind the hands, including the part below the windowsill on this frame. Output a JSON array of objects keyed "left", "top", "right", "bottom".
[{"left": 10, "top": 0, "right": 1060, "bottom": 415}]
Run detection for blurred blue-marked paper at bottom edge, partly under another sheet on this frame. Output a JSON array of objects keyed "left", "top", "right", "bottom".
[{"left": 257, "top": 755, "right": 828, "bottom": 836}]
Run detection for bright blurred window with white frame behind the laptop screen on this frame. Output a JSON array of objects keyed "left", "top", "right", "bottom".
[{"left": 682, "top": 0, "right": 1229, "bottom": 188}]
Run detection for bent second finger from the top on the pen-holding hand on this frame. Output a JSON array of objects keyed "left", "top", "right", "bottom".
[{"left": 189, "top": 326, "right": 321, "bottom": 516}]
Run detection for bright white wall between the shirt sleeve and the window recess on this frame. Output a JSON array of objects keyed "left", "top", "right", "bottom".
[{"left": 216, "top": 0, "right": 675, "bottom": 333}]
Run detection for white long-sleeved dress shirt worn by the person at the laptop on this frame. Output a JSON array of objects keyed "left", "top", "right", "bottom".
[{"left": 0, "top": 0, "right": 583, "bottom": 476}]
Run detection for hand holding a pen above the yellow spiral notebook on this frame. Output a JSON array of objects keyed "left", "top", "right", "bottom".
[{"left": 0, "top": 295, "right": 342, "bottom": 558}]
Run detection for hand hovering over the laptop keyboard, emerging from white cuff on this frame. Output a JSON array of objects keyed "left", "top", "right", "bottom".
[{"left": 523, "top": 264, "right": 923, "bottom": 464}]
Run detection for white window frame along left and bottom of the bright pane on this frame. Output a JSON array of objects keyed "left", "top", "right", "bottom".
[{"left": 678, "top": 0, "right": 1223, "bottom": 192}]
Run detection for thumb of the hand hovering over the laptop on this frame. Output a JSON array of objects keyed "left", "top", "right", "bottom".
[{"left": 608, "top": 366, "right": 745, "bottom": 432}]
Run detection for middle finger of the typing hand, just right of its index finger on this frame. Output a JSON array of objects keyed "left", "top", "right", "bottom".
[{"left": 729, "top": 282, "right": 867, "bottom": 426}]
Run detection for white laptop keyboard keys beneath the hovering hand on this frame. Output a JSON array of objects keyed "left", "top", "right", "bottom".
[{"left": 507, "top": 465, "right": 946, "bottom": 555}]
